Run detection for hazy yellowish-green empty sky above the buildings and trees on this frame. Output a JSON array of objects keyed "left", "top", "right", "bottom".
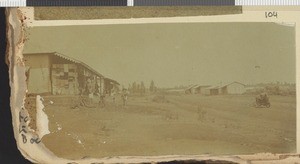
[{"left": 24, "top": 23, "right": 296, "bottom": 87}]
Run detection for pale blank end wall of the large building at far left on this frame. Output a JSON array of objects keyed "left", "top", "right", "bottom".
[{"left": 24, "top": 54, "right": 51, "bottom": 94}]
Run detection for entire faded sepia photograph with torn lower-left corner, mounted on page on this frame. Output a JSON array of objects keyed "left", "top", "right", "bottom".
[{"left": 19, "top": 22, "right": 297, "bottom": 159}]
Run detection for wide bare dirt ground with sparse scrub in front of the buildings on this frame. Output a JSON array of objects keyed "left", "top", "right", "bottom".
[{"left": 42, "top": 95, "right": 296, "bottom": 159}]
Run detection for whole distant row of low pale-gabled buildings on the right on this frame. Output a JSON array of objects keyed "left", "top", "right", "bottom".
[{"left": 185, "top": 82, "right": 246, "bottom": 95}]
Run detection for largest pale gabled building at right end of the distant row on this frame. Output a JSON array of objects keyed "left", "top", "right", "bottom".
[{"left": 204, "top": 82, "right": 246, "bottom": 95}]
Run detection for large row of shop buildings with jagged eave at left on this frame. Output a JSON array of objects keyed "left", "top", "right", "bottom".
[{"left": 24, "top": 52, "right": 120, "bottom": 95}]
